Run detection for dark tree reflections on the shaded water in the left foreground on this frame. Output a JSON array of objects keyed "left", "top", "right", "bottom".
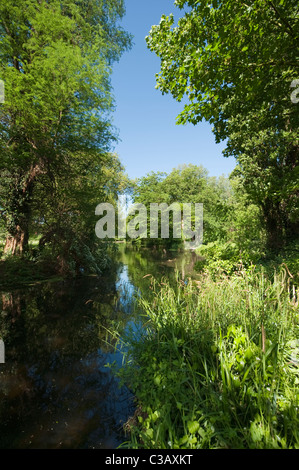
[{"left": 0, "top": 276, "right": 136, "bottom": 448}]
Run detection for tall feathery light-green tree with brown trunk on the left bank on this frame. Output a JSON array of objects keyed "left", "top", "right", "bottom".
[{"left": 0, "top": 0, "right": 130, "bottom": 254}]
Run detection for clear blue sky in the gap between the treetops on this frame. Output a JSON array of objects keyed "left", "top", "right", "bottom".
[{"left": 112, "top": 0, "right": 235, "bottom": 178}]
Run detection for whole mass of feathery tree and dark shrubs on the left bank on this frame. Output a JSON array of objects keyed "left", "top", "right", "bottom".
[{"left": 0, "top": 0, "right": 131, "bottom": 275}]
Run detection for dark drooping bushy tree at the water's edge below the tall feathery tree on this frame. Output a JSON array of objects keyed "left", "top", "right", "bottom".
[{"left": 30, "top": 153, "right": 128, "bottom": 275}]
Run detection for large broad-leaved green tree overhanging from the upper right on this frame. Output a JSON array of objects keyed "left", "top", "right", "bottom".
[{"left": 147, "top": 0, "right": 299, "bottom": 250}]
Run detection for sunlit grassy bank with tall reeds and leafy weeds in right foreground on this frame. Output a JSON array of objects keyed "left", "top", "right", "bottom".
[{"left": 118, "top": 269, "right": 299, "bottom": 449}]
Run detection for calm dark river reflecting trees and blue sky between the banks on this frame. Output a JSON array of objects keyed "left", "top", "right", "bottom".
[{"left": 0, "top": 245, "right": 202, "bottom": 449}]
